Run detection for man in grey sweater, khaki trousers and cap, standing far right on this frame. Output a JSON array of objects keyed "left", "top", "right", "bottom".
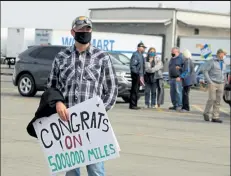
[{"left": 204, "top": 49, "right": 226, "bottom": 123}]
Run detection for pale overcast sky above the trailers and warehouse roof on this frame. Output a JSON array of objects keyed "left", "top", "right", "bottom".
[{"left": 1, "top": 1, "right": 230, "bottom": 29}]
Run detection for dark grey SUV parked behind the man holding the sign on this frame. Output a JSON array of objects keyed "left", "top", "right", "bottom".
[{"left": 13, "top": 45, "right": 143, "bottom": 102}]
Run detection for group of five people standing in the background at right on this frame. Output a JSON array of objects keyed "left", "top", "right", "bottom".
[{"left": 129, "top": 43, "right": 226, "bottom": 123}]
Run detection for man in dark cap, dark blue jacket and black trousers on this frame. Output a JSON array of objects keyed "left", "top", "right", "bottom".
[{"left": 129, "top": 42, "right": 147, "bottom": 110}]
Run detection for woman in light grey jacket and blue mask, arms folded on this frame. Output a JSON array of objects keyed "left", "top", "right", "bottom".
[{"left": 144, "top": 48, "right": 163, "bottom": 108}]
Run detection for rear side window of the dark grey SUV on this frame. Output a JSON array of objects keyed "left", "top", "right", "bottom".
[{"left": 36, "top": 47, "right": 62, "bottom": 60}]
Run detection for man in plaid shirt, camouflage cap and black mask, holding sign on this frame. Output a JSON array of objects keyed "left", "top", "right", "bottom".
[{"left": 48, "top": 16, "right": 118, "bottom": 176}]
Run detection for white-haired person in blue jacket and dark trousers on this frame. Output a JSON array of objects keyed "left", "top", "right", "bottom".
[{"left": 180, "top": 49, "right": 196, "bottom": 111}]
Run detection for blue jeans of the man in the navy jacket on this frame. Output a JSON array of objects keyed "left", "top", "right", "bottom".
[{"left": 170, "top": 79, "right": 183, "bottom": 108}]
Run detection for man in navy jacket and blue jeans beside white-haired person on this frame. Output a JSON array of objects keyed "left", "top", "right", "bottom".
[{"left": 168, "top": 47, "right": 183, "bottom": 111}]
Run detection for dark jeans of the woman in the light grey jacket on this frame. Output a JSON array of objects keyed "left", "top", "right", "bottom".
[{"left": 145, "top": 82, "right": 156, "bottom": 106}]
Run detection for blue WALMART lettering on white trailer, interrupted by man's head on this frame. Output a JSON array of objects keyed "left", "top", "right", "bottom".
[{"left": 62, "top": 37, "right": 115, "bottom": 51}]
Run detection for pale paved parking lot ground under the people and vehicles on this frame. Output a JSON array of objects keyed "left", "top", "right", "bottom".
[{"left": 1, "top": 75, "right": 230, "bottom": 176}]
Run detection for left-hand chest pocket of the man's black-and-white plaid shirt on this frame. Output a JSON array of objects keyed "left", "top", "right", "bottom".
[{"left": 59, "top": 64, "right": 75, "bottom": 86}]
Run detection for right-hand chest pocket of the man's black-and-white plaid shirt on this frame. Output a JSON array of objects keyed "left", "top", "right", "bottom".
[{"left": 83, "top": 63, "right": 101, "bottom": 81}]
